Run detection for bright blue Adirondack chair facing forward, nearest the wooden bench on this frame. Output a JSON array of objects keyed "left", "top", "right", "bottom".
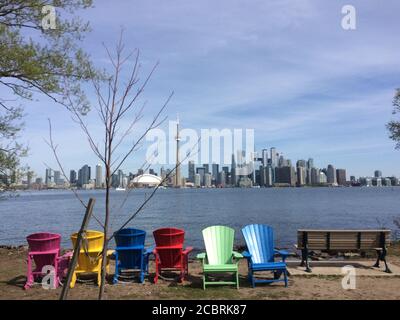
[{"left": 242, "top": 224, "right": 289, "bottom": 288}]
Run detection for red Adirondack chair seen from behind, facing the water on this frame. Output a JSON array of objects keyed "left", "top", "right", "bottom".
[{"left": 153, "top": 228, "right": 193, "bottom": 283}]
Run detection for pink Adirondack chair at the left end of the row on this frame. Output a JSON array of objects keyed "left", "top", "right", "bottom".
[{"left": 24, "top": 232, "right": 71, "bottom": 289}]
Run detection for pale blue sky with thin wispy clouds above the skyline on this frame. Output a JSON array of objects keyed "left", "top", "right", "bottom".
[{"left": 8, "top": 0, "right": 400, "bottom": 176}]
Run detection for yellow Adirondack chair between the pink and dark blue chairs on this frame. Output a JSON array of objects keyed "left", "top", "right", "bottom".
[{"left": 70, "top": 230, "right": 114, "bottom": 288}]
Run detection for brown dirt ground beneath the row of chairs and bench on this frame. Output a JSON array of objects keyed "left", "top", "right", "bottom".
[{"left": 0, "top": 245, "right": 400, "bottom": 300}]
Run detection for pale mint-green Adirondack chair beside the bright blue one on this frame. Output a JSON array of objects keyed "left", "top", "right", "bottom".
[{"left": 197, "top": 226, "right": 243, "bottom": 290}]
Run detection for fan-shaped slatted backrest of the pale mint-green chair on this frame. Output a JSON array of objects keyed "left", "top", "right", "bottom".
[{"left": 203, "top": 226, "right": 235, "bottom": 265}]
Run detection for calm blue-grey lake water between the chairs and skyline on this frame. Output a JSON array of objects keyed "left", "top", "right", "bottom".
[{"left": 0, "top": 187, "right": 400, "bottom": 249}]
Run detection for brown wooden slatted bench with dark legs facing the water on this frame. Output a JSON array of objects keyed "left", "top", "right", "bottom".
[{"left": 297, "top": 229, "right": 391, "bottom": 273}]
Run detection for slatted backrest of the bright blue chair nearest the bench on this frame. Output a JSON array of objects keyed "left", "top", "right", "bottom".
[{"left": 242, "top": 224, "right": 274, "bottom": 263}]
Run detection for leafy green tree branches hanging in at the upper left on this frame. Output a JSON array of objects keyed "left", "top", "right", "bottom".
[{"left": 0, "top": 0, "right": 98, "bottom": 188}]
